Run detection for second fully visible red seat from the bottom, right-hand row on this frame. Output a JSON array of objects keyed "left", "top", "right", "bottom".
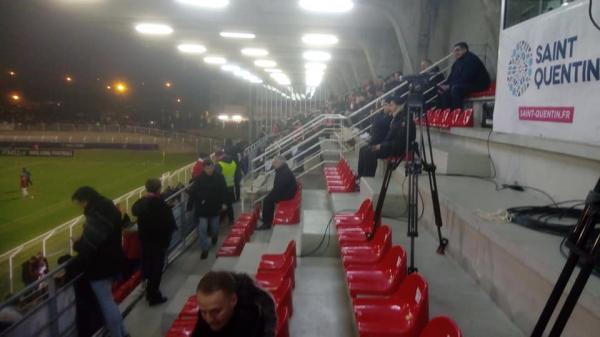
[{"left": 346, "top": 246, "right": 406, "bottom": 297}]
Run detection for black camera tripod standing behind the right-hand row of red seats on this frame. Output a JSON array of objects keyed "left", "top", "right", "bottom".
[{"left": 369, "top": 92, "right": 448, "bottom": 273}]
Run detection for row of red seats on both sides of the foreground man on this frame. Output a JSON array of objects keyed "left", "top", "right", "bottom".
[{"left": 167, "top": 241, "right": 296, "bottom": 337}]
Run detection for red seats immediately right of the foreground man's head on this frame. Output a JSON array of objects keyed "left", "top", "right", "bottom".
[{"left": 256, "top": 241, "right": 297, "bottom": 337}]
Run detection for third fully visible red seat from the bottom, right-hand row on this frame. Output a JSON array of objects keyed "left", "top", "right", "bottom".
[{"left": 340, "top": 226, "right": 392, "bottom": 269}]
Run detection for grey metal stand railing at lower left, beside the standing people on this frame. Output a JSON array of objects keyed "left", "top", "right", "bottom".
[{"left": 0, "top": 189, "right": 198, "bottom": 337}]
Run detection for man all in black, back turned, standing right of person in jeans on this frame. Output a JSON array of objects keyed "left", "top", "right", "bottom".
[{"left": 131, "top": 179, "right": 177, "bottom": 306}]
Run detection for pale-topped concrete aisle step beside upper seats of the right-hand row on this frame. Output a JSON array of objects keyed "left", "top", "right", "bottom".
[{"left": 299, "top": 210, "right": 339, "bottom": 257}]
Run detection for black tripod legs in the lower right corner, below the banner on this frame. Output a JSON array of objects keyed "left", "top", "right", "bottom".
[{"left": 531, "top": 179, "right": 600, "bottom": 337}]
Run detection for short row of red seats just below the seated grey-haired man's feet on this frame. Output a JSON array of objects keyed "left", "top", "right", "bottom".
[{"left": 217, "top": 205, "right": 260, "bottom": 257}]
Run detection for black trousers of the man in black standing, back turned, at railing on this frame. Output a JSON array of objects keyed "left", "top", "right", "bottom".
[{"left": 142, "top": 244, "right": 167, "bottom": 300}]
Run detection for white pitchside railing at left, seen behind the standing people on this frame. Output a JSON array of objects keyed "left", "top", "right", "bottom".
[{"left": 0, "top": 164, "right": 194, "bottom": 296}]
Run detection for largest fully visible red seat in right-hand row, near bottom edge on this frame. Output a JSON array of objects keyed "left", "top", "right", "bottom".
[{"left": 353, "top": 273, "right": 429, "bottom": 337}]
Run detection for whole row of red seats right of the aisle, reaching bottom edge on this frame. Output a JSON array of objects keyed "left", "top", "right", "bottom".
[{"left": 334, "top": 200, "right": 461, "bottom": 337}]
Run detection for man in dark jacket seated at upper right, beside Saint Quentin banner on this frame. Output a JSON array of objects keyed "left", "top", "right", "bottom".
[{"left": 438, "top": 42, "right": 490, "bottom": 109}]
